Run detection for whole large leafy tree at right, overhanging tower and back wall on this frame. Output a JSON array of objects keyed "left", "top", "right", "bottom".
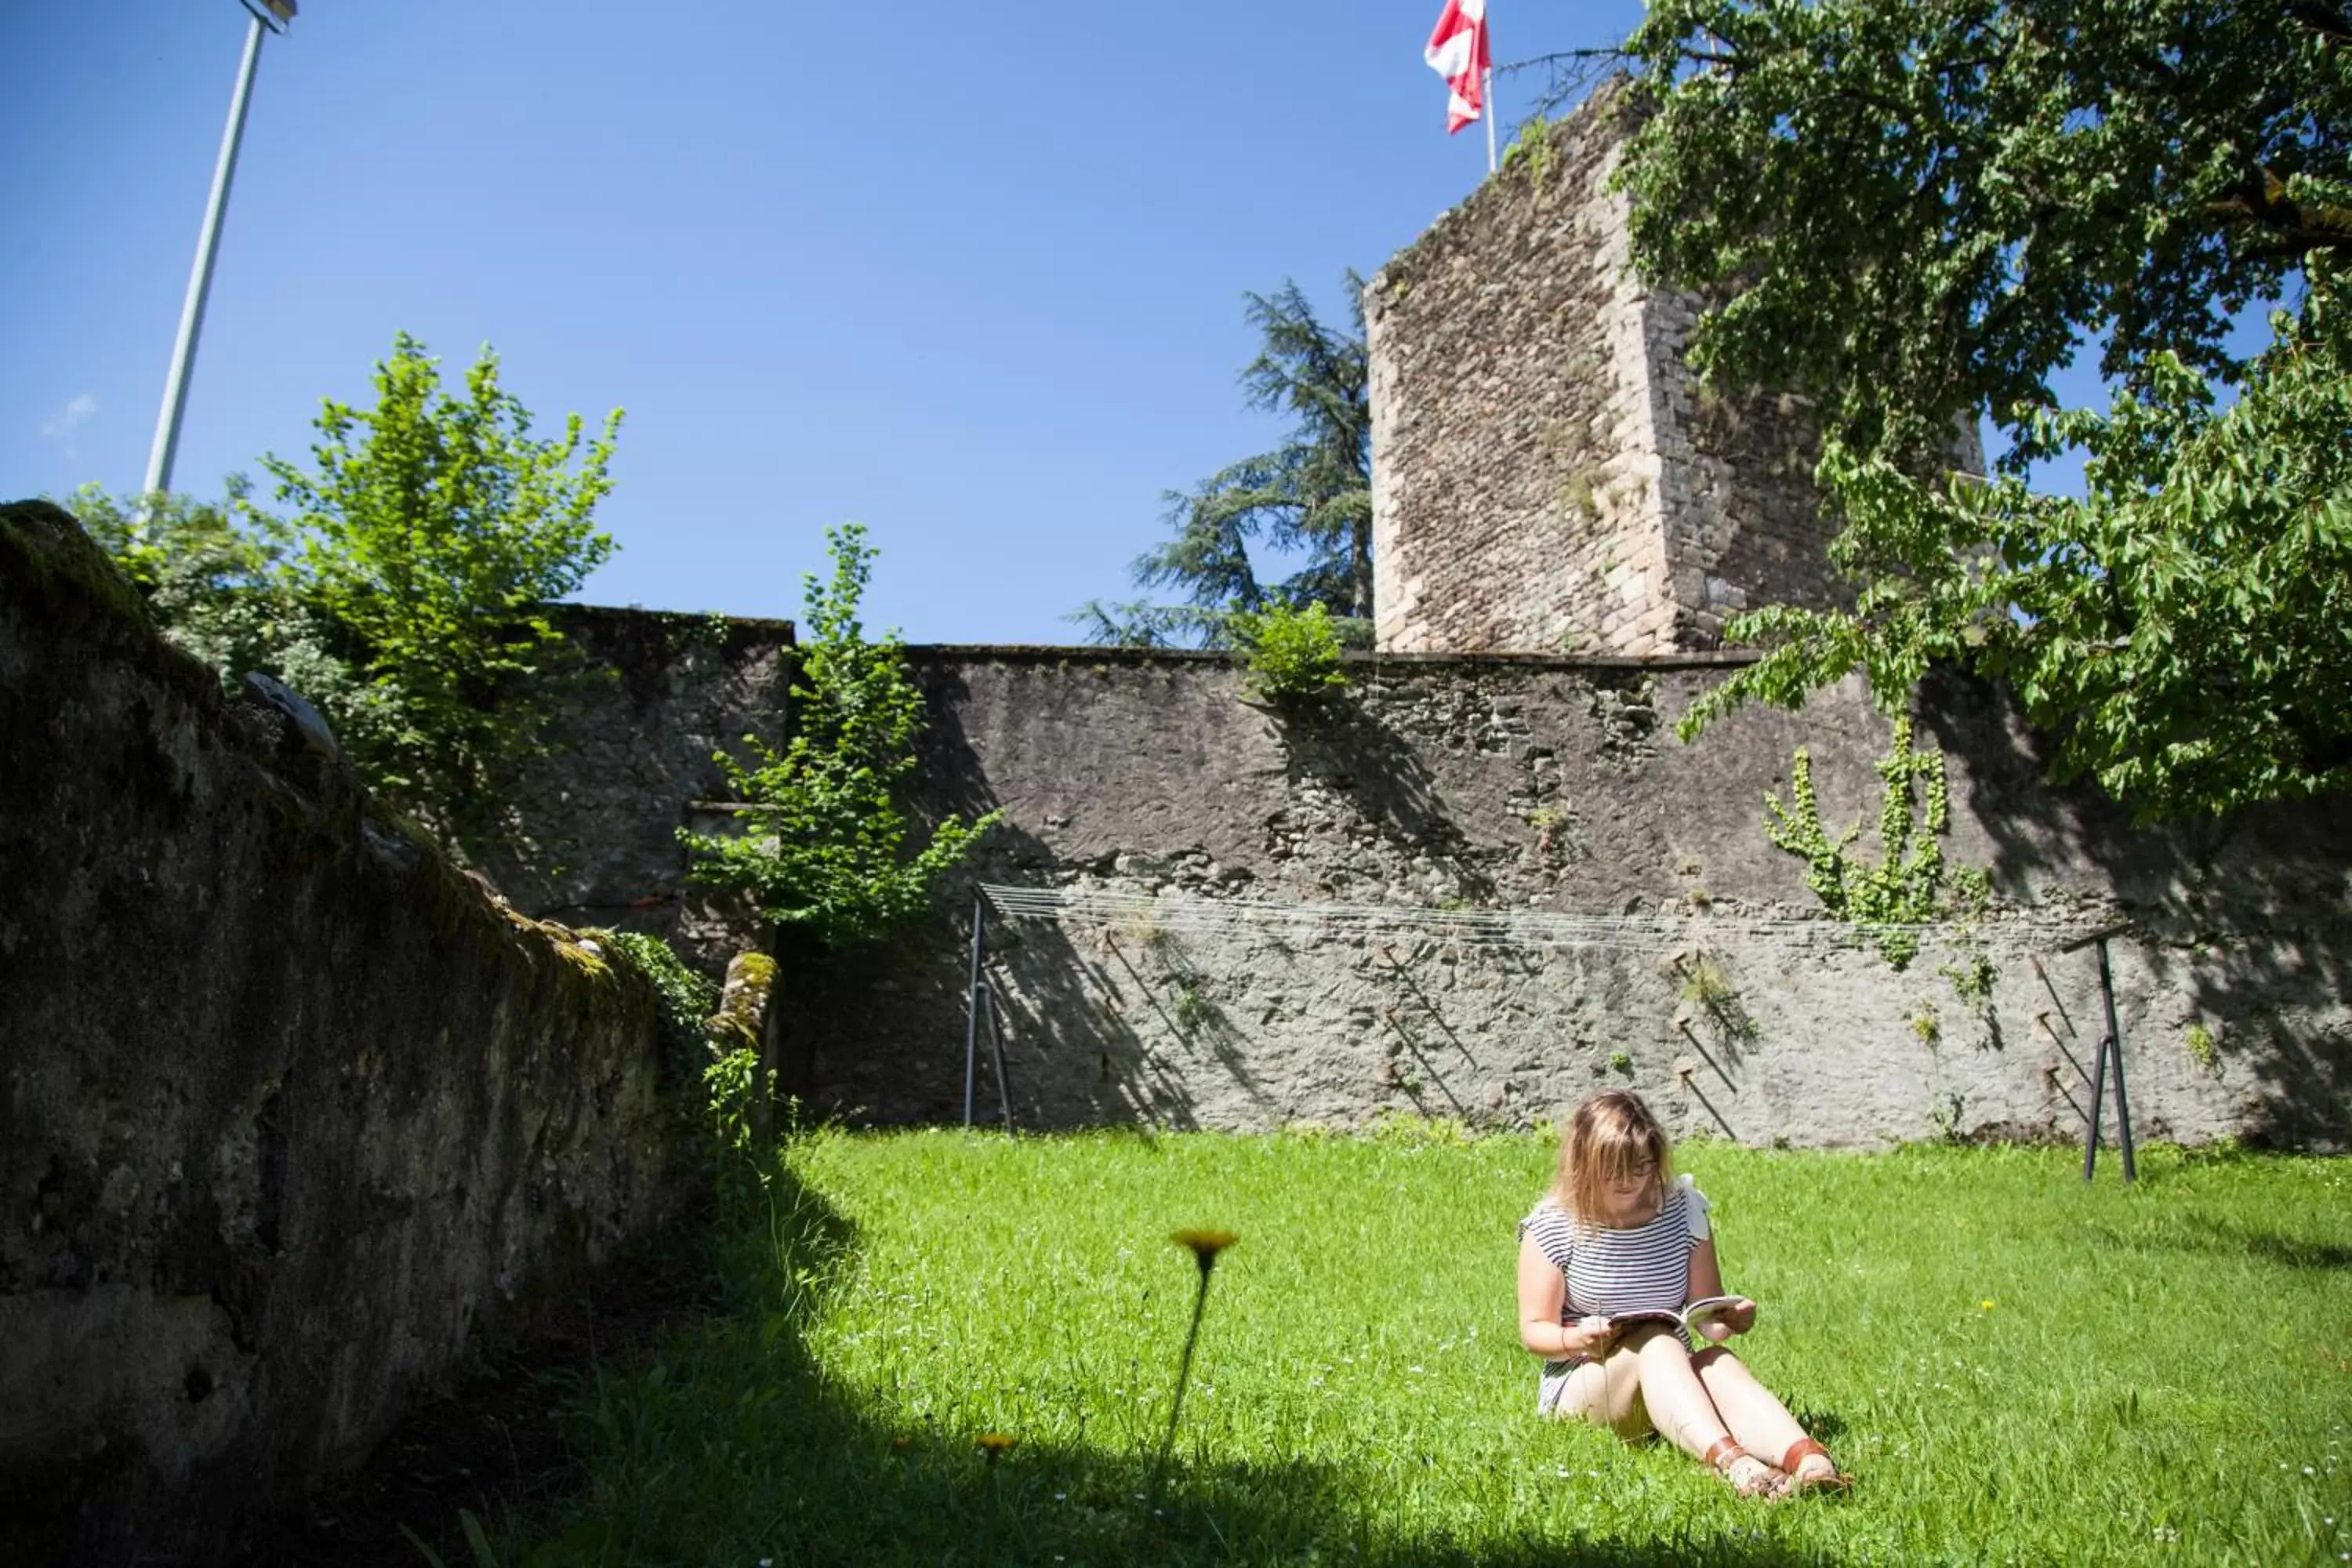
[{"left": 1623, "top": 0, "right": 2352, "bottom": 815}]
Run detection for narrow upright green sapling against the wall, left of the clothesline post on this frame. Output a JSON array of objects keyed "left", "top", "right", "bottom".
[{"left": 677, "top": 524, "right": 1000, "bottom": 947}]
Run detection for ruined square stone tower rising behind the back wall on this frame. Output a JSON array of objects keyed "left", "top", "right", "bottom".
[{"left": 1364, "top": 89, "right": 1837, "bottom": 656}]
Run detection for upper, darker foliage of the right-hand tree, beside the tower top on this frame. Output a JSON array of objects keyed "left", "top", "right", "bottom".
[{"left": 1623, "top": 0, "right": 2352, "bottom": 456}]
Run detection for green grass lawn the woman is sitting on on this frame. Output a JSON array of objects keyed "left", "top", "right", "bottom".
[{"left": 508, "top": 1131, "right": 2352, "bottom": 1568}]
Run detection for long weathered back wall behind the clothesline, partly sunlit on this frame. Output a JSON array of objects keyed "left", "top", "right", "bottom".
[{"left": 496, "top": 623, "right": 2352, "bottom": 1145}]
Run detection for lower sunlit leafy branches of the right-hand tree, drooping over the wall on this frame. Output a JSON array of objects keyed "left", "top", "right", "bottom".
[{"left": 1682, "top": 280, "right": 2352, "bottom": 818}]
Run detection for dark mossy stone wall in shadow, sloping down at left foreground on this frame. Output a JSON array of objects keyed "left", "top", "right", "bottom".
[{"left": 0, "top": 506, "right": 691, "bottom": 1563}]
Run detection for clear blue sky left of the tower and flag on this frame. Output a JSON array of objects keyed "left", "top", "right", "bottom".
[{"left": 0, "top": 0, "right": 1639, "bottom": 642}]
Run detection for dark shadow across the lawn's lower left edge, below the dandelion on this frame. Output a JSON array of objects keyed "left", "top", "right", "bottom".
[{"left": 503, "top": 1152, "right": 1813, "bottom": 1568}]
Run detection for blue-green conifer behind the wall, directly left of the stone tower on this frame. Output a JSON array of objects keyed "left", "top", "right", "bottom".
[{"left": 1070, "top": 270, "right": 1371, "bottom": 647}]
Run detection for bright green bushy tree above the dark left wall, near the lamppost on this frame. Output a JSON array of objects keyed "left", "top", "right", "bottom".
[{"left": 75, "top": 334, "right": 621, "bottom": 846}]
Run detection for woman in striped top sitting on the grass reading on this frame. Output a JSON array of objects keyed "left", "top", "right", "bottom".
[{"left": 1519, "top": 1091, "right": 1846, "bottom": 1497}]
